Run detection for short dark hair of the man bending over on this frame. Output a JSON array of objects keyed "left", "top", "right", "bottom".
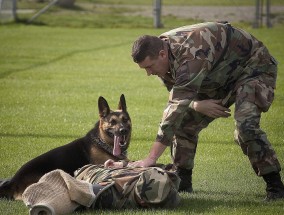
[{"left": 131, "top": 35, "right": 163, "bottom": 63}]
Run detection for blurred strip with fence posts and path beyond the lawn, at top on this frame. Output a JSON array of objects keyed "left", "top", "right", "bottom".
[{"left": 0, "top": 0, "right": 284, "bottom": 28}]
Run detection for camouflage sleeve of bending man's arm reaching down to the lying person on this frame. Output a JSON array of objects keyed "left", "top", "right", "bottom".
[{"left": 156, "top": 59, "right": 209, "bottom": 145}]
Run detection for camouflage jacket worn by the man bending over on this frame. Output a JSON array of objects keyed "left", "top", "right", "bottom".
[{"left": 156, "top": 22, "right": 277, "bottom": 145}]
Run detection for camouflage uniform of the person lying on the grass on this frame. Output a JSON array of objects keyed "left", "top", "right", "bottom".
[{"left": 75, "top": 164, "right": 180, "bottom": 209}]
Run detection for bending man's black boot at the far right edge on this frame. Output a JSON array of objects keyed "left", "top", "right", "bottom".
[{"left": 262, "top": 172, "right": 284, "bottom": 201}]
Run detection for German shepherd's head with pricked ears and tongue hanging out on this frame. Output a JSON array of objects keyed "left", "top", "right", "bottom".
[{"left": 98, "top": 94, "right": 132, "bottom": 156}]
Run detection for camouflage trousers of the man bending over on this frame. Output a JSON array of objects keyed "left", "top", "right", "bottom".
[{"left": 172, "top": 66, "right": 281, "bottom": 176}]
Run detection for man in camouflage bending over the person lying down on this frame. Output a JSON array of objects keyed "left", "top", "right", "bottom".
[{"left": 130, "top": 22, "right": 284, "bottom": 201}]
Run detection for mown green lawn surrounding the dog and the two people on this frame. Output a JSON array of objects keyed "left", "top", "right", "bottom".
[{"left": 0, "top": 2, "right": 284, "bottom": 215}]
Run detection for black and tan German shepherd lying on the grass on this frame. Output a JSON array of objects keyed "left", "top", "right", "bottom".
[{"left": 0, "top": 94, "right": 132, "bottom": 200}]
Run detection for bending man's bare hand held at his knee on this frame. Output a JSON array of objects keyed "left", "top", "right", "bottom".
[{"left": 193, "top": 99, "right": 231, "bottom": 118}]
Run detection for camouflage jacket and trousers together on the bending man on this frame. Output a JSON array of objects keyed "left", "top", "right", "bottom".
[{"left": 157, "top": 22, "right": 280, "bottom": 176}]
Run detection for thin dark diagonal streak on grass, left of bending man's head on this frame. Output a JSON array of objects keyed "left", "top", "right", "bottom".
[{"left": 0, "top": 41, "right": 131, "bottom": 79}]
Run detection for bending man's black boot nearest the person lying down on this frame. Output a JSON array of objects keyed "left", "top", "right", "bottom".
[{"left": 177, "top": 167, "right": 193, "bottom": 193}]
